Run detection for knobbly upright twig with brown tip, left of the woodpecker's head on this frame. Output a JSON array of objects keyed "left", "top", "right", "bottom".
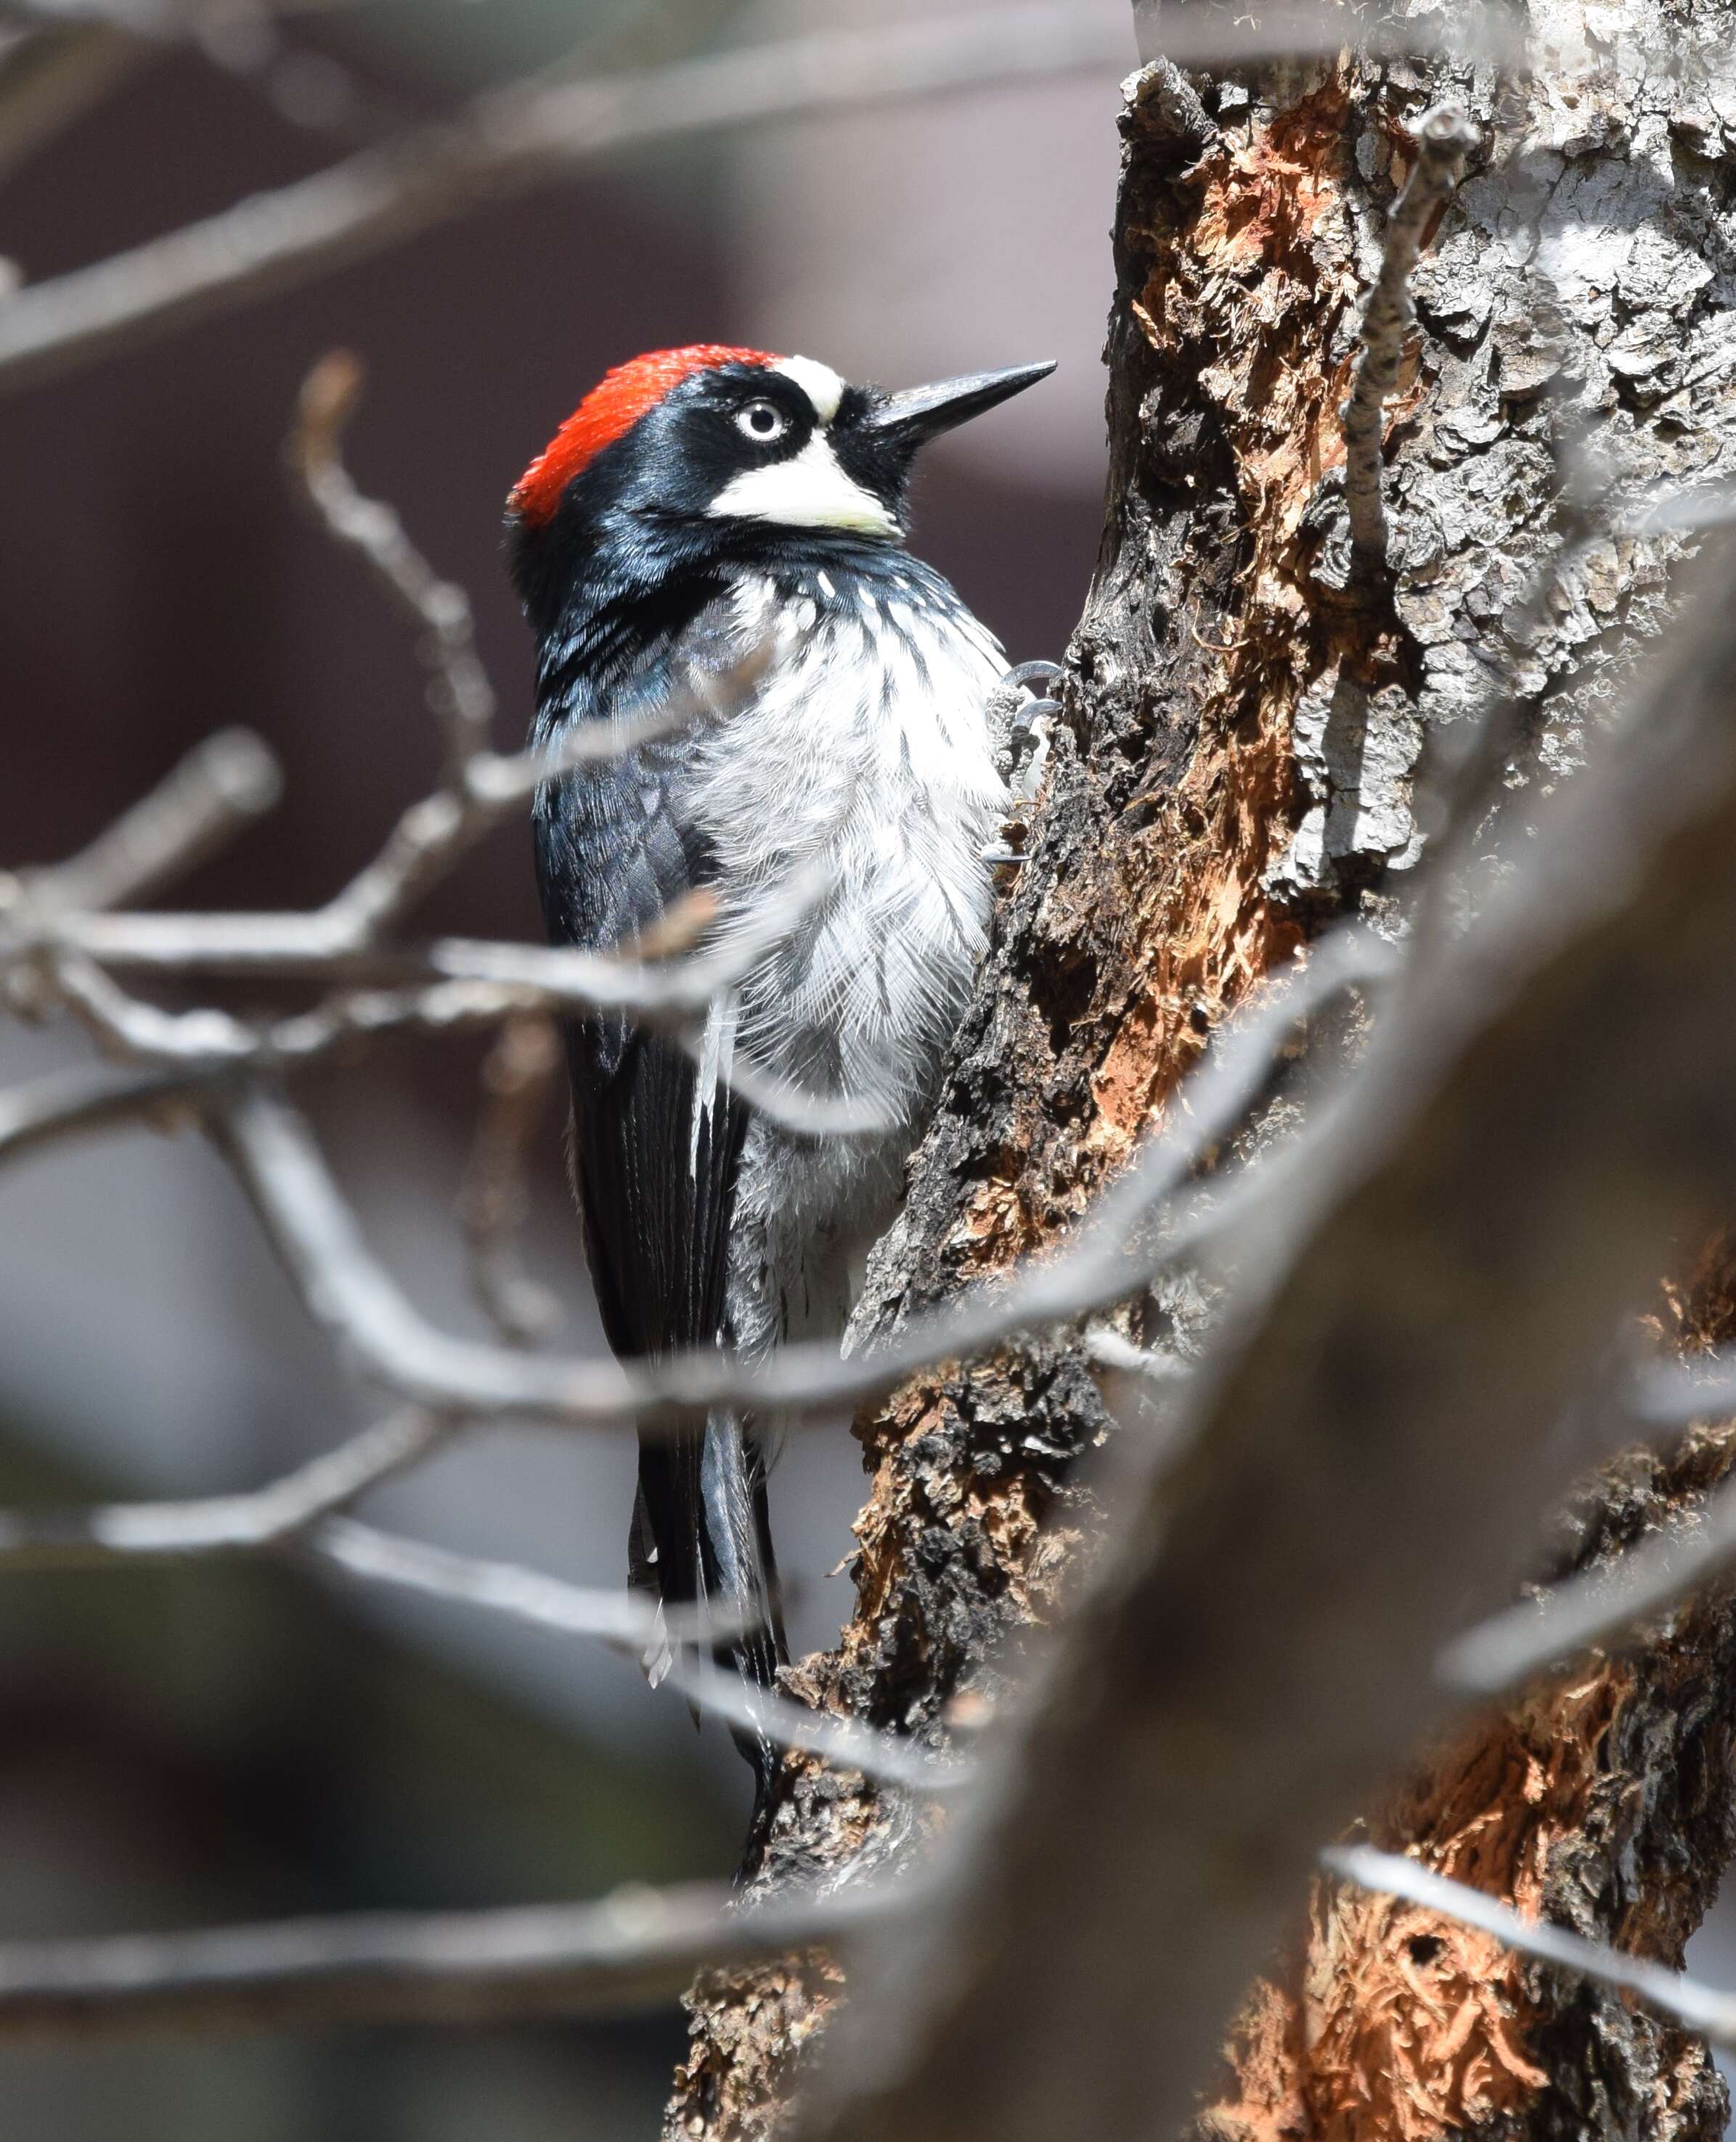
[{"left": 285, "top": 349, "right": 494, "bottom": 789}]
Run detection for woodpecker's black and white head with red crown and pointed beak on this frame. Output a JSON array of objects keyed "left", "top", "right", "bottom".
[{"left": 508, "top": 345, "right": 1054, "bottom": 621}]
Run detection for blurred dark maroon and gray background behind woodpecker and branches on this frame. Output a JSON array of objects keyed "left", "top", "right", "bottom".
[{"left": 0, "top": 0, "right": 1135, "bottom": 2142}]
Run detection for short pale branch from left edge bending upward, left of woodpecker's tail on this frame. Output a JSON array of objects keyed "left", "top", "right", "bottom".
[{"left": 0, "top": 1407, "right": 458, "bottom": 1570}]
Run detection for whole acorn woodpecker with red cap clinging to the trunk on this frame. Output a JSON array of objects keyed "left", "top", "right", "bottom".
[{"left": 508, "top": 345, "right": 1054, "bottom": 1801}]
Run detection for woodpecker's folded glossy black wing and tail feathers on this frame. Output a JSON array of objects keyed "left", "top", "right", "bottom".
[{"left": 535, "top": 611, "right": 783, "bottom": 1763}]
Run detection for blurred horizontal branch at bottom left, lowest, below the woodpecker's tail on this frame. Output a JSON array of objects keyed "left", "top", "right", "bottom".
[{"left": 0, "top": 1885, "right": 903, "bottom": 2041}]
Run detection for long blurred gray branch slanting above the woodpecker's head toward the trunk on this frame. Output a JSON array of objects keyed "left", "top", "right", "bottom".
[{"left": 0, "top": 4, "right": 1133, "bottom": 388}]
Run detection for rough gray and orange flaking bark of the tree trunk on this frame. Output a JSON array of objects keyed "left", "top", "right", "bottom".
[{"left": 666, "top": 0, "right": 1736, "bottom": 2142}]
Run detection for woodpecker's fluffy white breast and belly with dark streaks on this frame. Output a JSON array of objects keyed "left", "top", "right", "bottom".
[{"left": 682, "top": 582, "right": 1006, "bottom": 1123}]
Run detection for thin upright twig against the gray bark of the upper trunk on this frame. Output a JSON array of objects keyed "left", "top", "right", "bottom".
[{"left": 1344, "top": 105, "right": 1481, "bottom": 572}]
